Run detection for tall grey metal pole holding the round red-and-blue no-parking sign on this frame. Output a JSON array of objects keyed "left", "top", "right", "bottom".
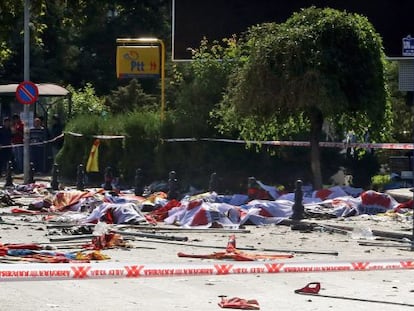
[{"left": 23, "top": 0, "right": 30, "bottom": 184}]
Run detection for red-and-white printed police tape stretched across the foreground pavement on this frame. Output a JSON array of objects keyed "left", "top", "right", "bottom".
[{"left": 0, "top": 259, "right": 414, "bottom": 282}]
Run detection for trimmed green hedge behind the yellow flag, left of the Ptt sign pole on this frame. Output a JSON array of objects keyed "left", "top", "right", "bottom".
[{"left": 57, "top": 111, "right": 162, "bottom": 185}]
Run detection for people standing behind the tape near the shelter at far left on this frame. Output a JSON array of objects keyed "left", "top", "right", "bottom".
[{"left": 0, "top": 114, "right": 63, "bottom": 176}]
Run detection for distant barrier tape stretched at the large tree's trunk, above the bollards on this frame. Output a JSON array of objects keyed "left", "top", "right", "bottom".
[{"left": 164, "top": 138, "right": 414, "bottom": 150}]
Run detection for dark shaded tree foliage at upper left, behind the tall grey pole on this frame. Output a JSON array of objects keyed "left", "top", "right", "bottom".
[{"left": 0, "top": 0, "right": 170, "bottom": 95}]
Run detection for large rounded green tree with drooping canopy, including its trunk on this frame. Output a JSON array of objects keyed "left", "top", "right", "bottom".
[{"left": 212, "top": 7, "right": 390, "bottom": 187}]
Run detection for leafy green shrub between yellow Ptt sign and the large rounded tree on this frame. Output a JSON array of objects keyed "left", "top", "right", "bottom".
[{"left": 170, "top": 37, "right": 243, "bottom": 137}]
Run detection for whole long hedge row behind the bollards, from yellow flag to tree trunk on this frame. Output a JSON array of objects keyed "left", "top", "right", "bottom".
[{"left": 57, "top": 109, "right": 366, "bottom": 193}]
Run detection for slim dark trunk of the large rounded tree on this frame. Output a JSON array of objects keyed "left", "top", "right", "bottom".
[{"left": 310, "top": 107, "right": 323, "bottom": 189}]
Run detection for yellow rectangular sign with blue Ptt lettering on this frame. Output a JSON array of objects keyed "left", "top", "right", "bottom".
[{"left": 116, "top": 46, "right": 161, "bottom": 79}]
